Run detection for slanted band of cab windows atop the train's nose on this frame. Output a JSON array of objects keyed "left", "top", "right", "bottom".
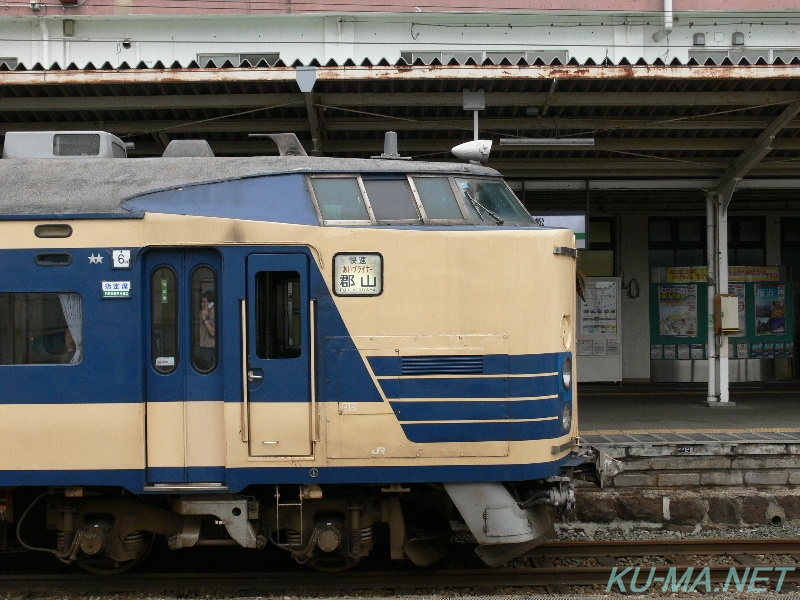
[{"left": 309, "top": 173, "right": 533, "bottom": 225}]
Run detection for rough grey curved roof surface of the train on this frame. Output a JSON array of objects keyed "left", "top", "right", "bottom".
[{"left": 0, "top": 156, "right": 500, "bottom": 219}]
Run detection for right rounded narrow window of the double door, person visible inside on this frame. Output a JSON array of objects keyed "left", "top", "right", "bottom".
[{"left": 192, "top": 267, "right": 219, "bottom": 373}]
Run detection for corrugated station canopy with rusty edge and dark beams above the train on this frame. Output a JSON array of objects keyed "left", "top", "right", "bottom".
[{"left": 0, "top": 58, "right": 800, "bottom": 210}]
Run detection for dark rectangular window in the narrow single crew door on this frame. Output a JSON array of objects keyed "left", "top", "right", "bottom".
[{"left": 256, "top": 271, "right": 302, "bottom": 358}]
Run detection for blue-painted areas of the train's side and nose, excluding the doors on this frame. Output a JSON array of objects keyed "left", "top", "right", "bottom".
[{"left": 0, "top": 238, "right": 571, "bottom": 493}]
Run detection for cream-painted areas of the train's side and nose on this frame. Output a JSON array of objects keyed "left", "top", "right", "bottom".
[{"left": 0, "top": 214, "right": 577, "bottom": 480}]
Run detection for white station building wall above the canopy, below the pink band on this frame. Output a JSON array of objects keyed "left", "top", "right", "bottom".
[{"left": 0, "top": 7, "right": 800, "bottom": 68}]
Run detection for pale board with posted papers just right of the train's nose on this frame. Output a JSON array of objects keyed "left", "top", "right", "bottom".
[{"left": 576, "top": 277, "right": 622, "bottom": 382}]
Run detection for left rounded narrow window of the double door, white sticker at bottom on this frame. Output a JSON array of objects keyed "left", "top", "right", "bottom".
[{"left": 151, "top": 267, "right": 178, "bottom": 373}]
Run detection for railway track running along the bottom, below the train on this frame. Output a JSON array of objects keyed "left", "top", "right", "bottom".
[{"left": 0, "top": 539, "right": 800, "bottom": 596}]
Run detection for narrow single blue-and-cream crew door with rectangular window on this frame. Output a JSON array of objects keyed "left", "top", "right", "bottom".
[{"left": 245, "top": 253, "right": 315, "bottom": 456}]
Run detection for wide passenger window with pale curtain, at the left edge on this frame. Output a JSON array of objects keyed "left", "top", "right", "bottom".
[{"left": 0, "top": 293, "right": 83, "bottom": 365}]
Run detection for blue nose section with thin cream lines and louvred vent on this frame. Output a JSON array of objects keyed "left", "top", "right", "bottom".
[{"left": 368, "top": 352, "right": 572, "bottom": 443}]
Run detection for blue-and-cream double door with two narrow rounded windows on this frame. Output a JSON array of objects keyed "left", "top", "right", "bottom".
[{"left": 145, "top": 249, "right": 226, "bottom": 484}]
